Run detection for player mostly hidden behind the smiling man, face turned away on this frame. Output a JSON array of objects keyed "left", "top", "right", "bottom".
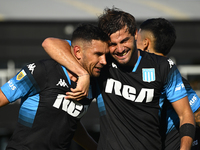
[{"left": 137, "top": 18, "right": 200, "bottom": 150}]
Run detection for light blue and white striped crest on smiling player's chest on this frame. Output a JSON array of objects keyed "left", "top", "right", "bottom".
[{"left": 142, "top": 68, "right": 156, "bottom": 82}]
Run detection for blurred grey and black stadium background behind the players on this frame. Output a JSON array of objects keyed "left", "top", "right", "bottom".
[{"left": 0, "top": 0, "right": 200, "bottom": 150}]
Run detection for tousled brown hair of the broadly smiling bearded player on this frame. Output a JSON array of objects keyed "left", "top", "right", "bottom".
[{"left": 98, "top": 7, "right": 137, "bottom": 36}]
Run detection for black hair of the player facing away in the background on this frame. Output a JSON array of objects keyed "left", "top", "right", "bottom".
[{"left": 140, "top": 18, "right": 176, "bottom": 55}]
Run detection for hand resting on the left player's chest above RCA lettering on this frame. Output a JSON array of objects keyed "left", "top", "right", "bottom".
[{"left": 65, "top": 74, "right": 90, "bottom": 101}]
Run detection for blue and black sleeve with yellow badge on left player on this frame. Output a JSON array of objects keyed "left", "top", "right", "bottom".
[{"left": 1, "top": 60, "right": 45, "bottom": 102}]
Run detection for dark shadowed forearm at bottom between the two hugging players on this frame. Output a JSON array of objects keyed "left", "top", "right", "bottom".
[{"left": 73, "top": 122, "right": 97, "bottom": 150}]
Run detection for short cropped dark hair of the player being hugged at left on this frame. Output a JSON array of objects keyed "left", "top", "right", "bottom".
[{"left": 71, "top": 24, "right": 109, "bottom": 42}]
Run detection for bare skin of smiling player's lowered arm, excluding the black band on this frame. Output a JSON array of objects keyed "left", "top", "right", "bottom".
[{"left": 172, "top": 96, "right": 195, "bottom": 150}]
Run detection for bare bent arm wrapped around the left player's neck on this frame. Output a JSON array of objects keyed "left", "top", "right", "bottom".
[{"left": 42, "top": 38, "right": 90, "bottom": 100}]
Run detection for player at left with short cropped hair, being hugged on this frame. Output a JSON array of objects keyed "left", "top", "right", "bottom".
[{"left": 0, "top": 24, "right": 109, "bottom": 150}]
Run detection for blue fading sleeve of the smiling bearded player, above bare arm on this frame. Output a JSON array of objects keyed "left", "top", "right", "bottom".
[{"left": 161, "top": 58, "right": 187, "bottom": 103}]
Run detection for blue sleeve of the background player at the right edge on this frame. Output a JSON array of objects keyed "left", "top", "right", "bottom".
[{"left": 182, "top": 78, "right": 200, "bottom": 112}]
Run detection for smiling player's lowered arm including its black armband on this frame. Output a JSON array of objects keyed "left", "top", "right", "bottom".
[{"left": 172, "top": 96, "right": 195, "bottom": 150}]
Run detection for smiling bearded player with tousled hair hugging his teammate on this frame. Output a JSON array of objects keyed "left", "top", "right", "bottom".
[{"left": 43, "top": 8, "right": 195, "bottom": 150}]
